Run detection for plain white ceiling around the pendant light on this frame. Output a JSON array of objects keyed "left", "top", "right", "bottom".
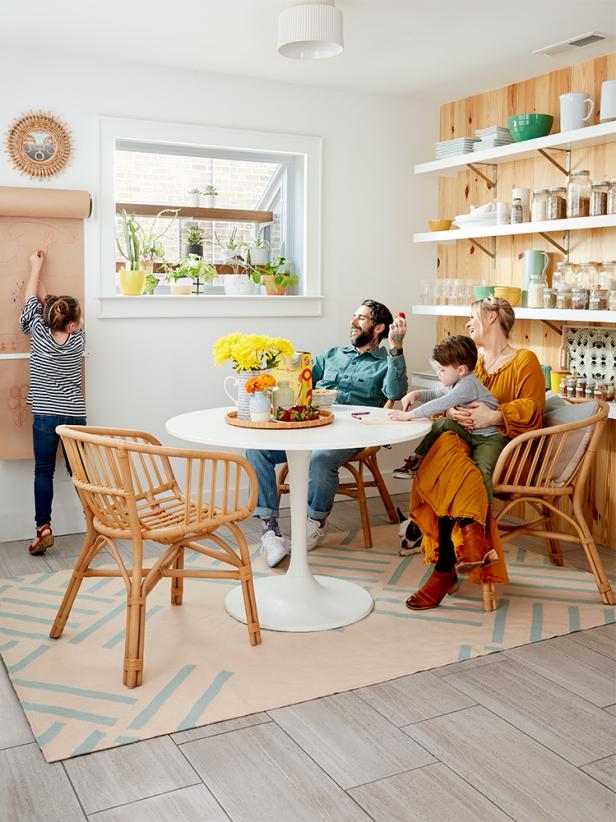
[{"left": 0, "top": 0, "right": 616, "bottom": 102}]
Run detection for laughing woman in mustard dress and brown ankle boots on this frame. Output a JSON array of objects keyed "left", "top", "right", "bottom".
[{"left": 406, "top": 297, "right": 545, "bottom": 610}]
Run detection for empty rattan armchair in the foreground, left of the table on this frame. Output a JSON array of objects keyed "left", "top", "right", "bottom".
[{"left": 50, "top": 425, "right": 261, "bottom": 688}]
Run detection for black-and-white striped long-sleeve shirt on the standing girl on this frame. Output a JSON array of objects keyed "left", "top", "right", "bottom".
[{"left": 19, "top": 297, "right": 86, "bottom": 417}]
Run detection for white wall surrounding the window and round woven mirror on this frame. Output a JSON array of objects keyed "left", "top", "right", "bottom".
[{"left": 0, "top": 52, "right": 438, "bottom": 540}]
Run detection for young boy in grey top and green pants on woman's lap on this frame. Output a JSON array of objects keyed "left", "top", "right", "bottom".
[{"left": 388, "top": 335, "right": 507, "bottom": 504}]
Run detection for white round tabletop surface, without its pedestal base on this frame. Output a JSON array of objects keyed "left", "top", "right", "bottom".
[{"left": 165, "top": 405, "right": 430, "bottom": 451}]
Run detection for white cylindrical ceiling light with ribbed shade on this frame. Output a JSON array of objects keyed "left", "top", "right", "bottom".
[{"left": 278, "top": 0, "right": 344, "bottom": 60}]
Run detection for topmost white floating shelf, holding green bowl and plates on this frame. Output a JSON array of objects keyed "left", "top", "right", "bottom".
[{"left": 415, "top": 121, "right": 616, "bottom": 176}]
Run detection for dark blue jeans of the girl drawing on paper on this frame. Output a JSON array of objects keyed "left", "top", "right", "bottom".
[{"left": 32, "top": 414, "right": 86, "bottom": 528}]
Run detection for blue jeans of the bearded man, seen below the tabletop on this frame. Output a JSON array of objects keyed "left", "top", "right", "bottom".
[{"left": 246, "top": 448, "right": 362, "bottom": 520}]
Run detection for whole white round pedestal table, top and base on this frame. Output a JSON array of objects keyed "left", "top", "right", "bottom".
[{"left": 166, "top": 405, "right": 430, "bottom": 631}]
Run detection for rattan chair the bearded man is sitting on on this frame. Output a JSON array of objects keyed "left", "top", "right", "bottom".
[{"left": 278, "top": 400, "right": 399, "bottom": 548}]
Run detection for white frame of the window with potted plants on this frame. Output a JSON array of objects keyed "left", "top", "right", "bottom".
[{"left": 98, "top": 117, "right": 323, "bottom": 319}]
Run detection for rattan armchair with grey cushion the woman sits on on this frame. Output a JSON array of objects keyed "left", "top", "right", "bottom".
[{"left": 484, "top": 401, "right": 614, "bottom": 605}]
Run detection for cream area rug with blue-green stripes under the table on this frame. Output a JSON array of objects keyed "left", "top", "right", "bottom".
[{"left": 0, "top": 526, "right": 615, "bottom": 762}]
